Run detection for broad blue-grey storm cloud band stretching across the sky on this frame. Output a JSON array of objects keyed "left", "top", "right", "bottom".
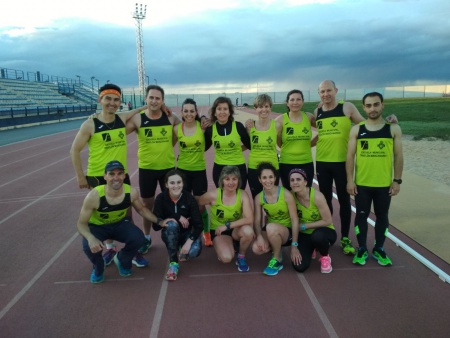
[{"left": 0, "top": 1, "right": 450, "bottom": 87}]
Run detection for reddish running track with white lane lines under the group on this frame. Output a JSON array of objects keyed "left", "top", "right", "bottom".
[{"left": 0, "top": 113, "right": 450, "bottom": 338}]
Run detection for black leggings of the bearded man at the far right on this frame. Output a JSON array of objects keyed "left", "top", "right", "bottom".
[{"left": 355, "top": 185, "right": 391, "bottom": 247}]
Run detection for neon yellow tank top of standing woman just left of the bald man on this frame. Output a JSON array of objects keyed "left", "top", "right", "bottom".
[{"left": 280, "top": 112, "right": 313, "bottom": 164}]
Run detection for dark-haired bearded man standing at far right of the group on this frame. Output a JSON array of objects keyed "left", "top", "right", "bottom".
[{"left": 347, "top": 92, "right": 403, "bottom": 266}]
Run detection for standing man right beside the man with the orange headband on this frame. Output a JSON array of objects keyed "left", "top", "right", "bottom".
[{"left": 127, "top": 85, "right": 180, "bottom": 254}]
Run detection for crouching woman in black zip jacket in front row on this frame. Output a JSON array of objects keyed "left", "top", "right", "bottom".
[{"left": 153, "top": 169, "right": 203, "bottom": 281}]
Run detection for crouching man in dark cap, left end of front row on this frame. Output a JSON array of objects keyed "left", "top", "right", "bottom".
[{"left": 77, "top": 161, "right": 170, "bottom": 284}]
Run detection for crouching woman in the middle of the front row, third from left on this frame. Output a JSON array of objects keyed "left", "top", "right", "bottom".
[{"left": 199, "top": 166, "right": 255, "bottom": 272}]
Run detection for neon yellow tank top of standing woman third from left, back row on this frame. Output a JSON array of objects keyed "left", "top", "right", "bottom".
[{"left": 177, "top": 121, "right": 206, "bottom": 170}]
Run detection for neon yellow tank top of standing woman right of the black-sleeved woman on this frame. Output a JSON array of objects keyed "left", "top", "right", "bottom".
[{"left": 248, "top": 120, "right": 278, "bottom": 169}]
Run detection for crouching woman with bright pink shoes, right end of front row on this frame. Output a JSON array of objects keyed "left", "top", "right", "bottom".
[{"left": 289, "top": 169, "right": 337, "bottom": 273}]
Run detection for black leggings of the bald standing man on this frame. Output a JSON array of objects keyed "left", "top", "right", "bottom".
[{"left": 316, "top": 162, "right": 352, "bottom": 237}]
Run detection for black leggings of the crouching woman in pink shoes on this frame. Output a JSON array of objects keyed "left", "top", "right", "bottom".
[{"left": 292, "top": 227, "right": 337, "bottom": 272}]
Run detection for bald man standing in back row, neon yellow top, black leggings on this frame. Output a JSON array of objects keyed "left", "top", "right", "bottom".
[{"left": 314, "top": 80, "right": 364, "bottom": 255}]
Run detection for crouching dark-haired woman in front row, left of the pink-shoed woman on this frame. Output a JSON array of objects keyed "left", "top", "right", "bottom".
[{"left": 252, "top": 162, "right": 299, "bottom": 276}]
